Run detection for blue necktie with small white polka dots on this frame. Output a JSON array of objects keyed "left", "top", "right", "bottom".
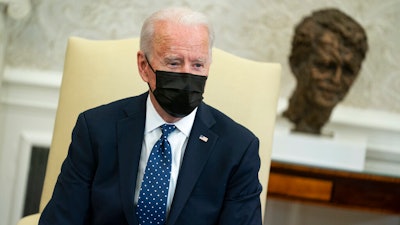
[{"left": 136, "top": 124, "right": 176, "bottom": 225}]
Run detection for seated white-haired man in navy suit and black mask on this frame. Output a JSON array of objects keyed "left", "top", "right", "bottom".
[{"left": 39, "top": 8, "right": 262, "bottom": 225}]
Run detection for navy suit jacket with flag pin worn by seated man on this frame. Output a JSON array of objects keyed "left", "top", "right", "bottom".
[{"left": 39, "top": 93, "right": 262, "bottom": 225}]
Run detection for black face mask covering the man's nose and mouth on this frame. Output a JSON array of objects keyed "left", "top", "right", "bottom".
[{"left": 146, "top": 57, "right": 207, "bottom": 118}]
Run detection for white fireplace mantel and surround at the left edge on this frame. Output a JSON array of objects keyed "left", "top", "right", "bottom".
[{"left": 0, "top": 67, "right": 62, "bottom": 224}]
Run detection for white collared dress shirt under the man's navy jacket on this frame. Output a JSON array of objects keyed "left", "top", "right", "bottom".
[{"left": 134, "top": 96, "right": 197, "bottom": 215}]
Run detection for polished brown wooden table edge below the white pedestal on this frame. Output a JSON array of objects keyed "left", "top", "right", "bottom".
[{"left": 268, "top": 161, "right": 400, "bottom": 214}]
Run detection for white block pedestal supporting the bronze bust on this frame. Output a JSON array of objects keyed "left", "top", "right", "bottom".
[{"left": 272, "top": 126, "right": 367, "bottom": 171}]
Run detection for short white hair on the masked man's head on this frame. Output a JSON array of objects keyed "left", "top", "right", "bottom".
[{"left": 140, "top": 7, "right": 214, "bottom": 56}]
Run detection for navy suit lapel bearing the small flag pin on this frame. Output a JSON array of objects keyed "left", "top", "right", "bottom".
[{"left": 167, "top": 103, "right": 218, "bottom": 224}]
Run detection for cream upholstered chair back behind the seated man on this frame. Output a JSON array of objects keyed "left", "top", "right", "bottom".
[{"left": 40, "top": 37, "right": 281, "bottom": 221}]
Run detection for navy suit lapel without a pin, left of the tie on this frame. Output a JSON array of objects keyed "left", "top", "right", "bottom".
[{"left": 117, "top": 95, "right": 147, "bottom": 225}]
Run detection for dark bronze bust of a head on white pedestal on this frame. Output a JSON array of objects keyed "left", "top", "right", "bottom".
[{"left": 283, "top": 9, "right": 368, "bottom": 134}]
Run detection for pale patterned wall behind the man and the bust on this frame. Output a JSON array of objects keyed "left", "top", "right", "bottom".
[{"left": 0, "top": 0, "right": 400, "bottom": 113}]
